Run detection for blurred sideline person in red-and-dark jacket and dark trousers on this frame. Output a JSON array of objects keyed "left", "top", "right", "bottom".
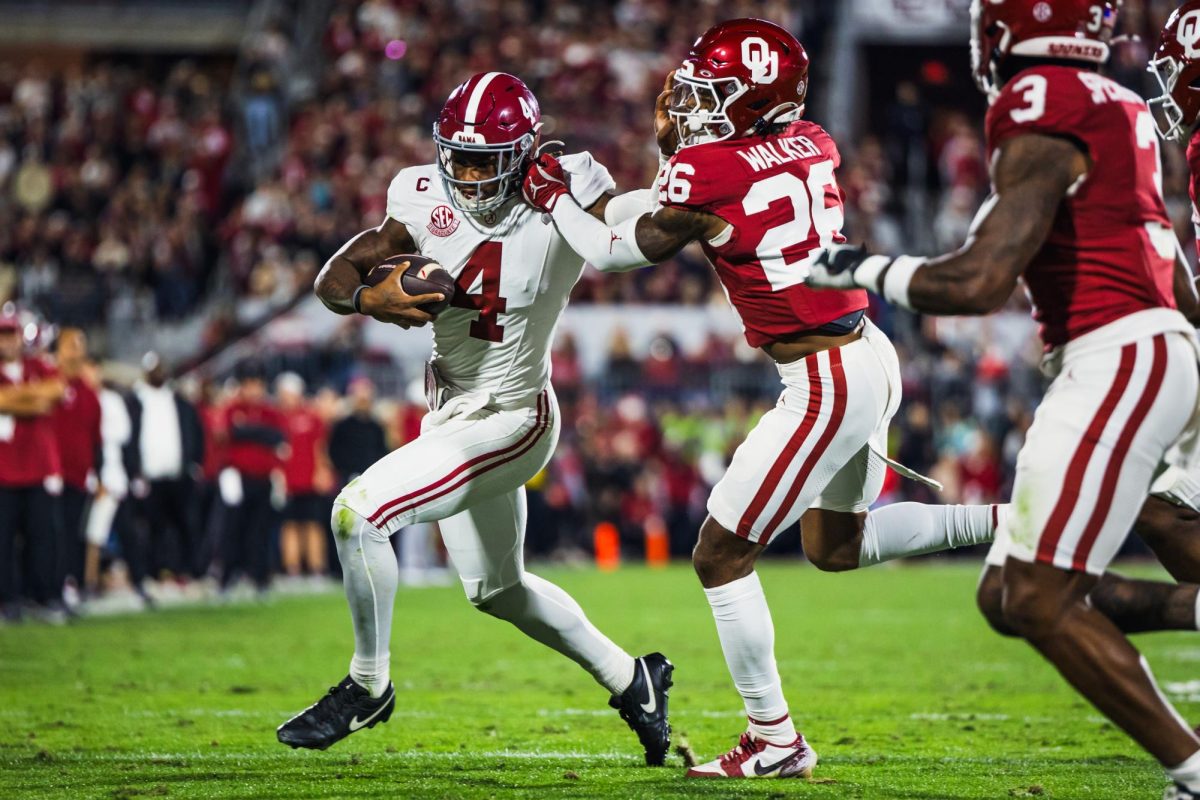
[{"left": 218, "top": 363, "right": 288, "bottom": 594}]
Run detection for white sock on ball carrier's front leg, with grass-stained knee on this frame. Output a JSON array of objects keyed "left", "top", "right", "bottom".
[{"left": 334, "top": 506, "right": 398, "bottom": 697}]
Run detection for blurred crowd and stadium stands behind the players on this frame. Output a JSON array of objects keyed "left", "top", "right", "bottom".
[{"left": 0, "top": 0, "right": 1194, "bottom": 614}]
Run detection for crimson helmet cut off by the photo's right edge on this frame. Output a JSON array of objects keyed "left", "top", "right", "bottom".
[{"left": 1147, "top": 0, "right": 1200, "bottom": 142}]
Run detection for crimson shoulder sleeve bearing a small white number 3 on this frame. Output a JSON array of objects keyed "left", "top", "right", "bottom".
[{"left": 985, "top": 70, "right": 1091, "bottom": 151}]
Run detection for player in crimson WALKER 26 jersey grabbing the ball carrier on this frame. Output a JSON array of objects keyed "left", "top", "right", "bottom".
[{"left": 523, "top": 19, "right": 997, "bottom": 777}]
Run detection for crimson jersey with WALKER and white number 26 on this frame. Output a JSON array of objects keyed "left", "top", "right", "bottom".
[{"left": 658, "top": 120, "right": 866, "bottom": 347}]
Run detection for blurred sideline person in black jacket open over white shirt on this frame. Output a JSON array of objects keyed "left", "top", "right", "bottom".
[{"left": 126, "top": 351, "right": 208, "bottom": 581}]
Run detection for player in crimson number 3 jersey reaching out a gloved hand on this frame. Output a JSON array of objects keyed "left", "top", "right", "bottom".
[{"left": 810, "top": 0, "right": 1200, "bottom": 798}]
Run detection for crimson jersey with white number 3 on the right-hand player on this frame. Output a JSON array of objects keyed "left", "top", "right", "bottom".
[{"left": 986, "top": 66, "right": 1176, "bottom": 349}]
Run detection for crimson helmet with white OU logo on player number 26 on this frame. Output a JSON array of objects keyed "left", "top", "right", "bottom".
[{"left": 670, "top": 19, "right": 809, "bottom": 148}]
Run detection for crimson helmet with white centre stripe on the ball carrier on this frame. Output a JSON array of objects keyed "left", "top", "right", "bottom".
[{"left": 433, "top": 72, "right": 541, "bottom": 213}]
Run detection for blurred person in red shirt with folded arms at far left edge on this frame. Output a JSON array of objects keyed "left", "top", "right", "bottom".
[{"left": 0, "top": 306, "right": 66, "bottom": 624}]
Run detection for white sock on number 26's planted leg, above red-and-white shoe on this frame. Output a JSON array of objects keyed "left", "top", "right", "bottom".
[{"left": 704, "top": 572, "right": 796, "bottom": 745}]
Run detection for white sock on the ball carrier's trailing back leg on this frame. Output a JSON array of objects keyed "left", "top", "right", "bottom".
[{"left": 482, "top": 572, "right": 635, "bottom": 694}]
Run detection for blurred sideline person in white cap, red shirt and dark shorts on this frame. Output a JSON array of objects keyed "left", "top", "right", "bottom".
[{"left": 275, "top": 372, "right": 334, "bottom": 578}]
